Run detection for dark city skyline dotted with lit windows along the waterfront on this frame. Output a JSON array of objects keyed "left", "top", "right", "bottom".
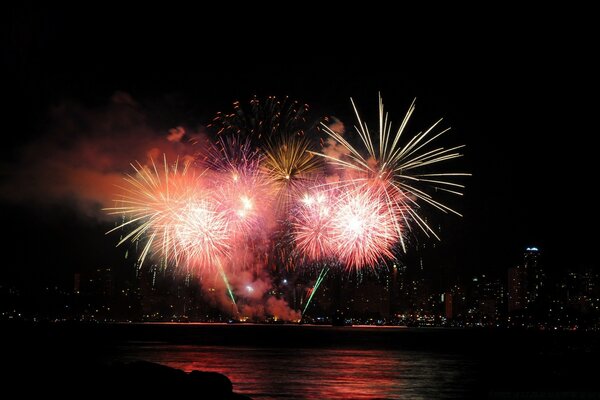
[{"left": 0, "top": 247, "right": 600, "bottom": 331}]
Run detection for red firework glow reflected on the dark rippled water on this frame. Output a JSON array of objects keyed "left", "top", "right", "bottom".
[{"left": 129, "top": 346, "right": 406, "bottom": 399}]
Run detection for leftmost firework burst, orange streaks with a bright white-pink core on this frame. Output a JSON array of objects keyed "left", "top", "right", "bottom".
[{"left": 107, "top": 157, "right": 230, "bottom": 269}]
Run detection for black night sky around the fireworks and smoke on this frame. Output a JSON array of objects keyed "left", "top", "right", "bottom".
[{"left": 0, "top": 7, "right": 598, "bottom": 290}]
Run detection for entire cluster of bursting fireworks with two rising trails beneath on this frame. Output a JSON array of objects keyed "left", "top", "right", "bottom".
[{"left": 108, "top": 97, "right": 468, "bottom": 313}]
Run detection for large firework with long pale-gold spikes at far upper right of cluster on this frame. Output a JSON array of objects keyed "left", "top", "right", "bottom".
[{"left": 315, "top": 97, "right": 469, "bottom": 250}]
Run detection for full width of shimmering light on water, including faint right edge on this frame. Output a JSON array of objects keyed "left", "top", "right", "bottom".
[{"left": 119, "top": 343, "right": 477, "bottom": 399}]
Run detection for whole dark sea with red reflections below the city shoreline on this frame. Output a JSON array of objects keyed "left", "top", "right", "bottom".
[{"left": 3, "top": 323, "right": 600, "bottom": 399}]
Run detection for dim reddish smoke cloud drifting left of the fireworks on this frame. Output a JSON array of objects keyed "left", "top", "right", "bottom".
[{"left": 0, "top": 92, "right": 198, "bottom": 218}]
